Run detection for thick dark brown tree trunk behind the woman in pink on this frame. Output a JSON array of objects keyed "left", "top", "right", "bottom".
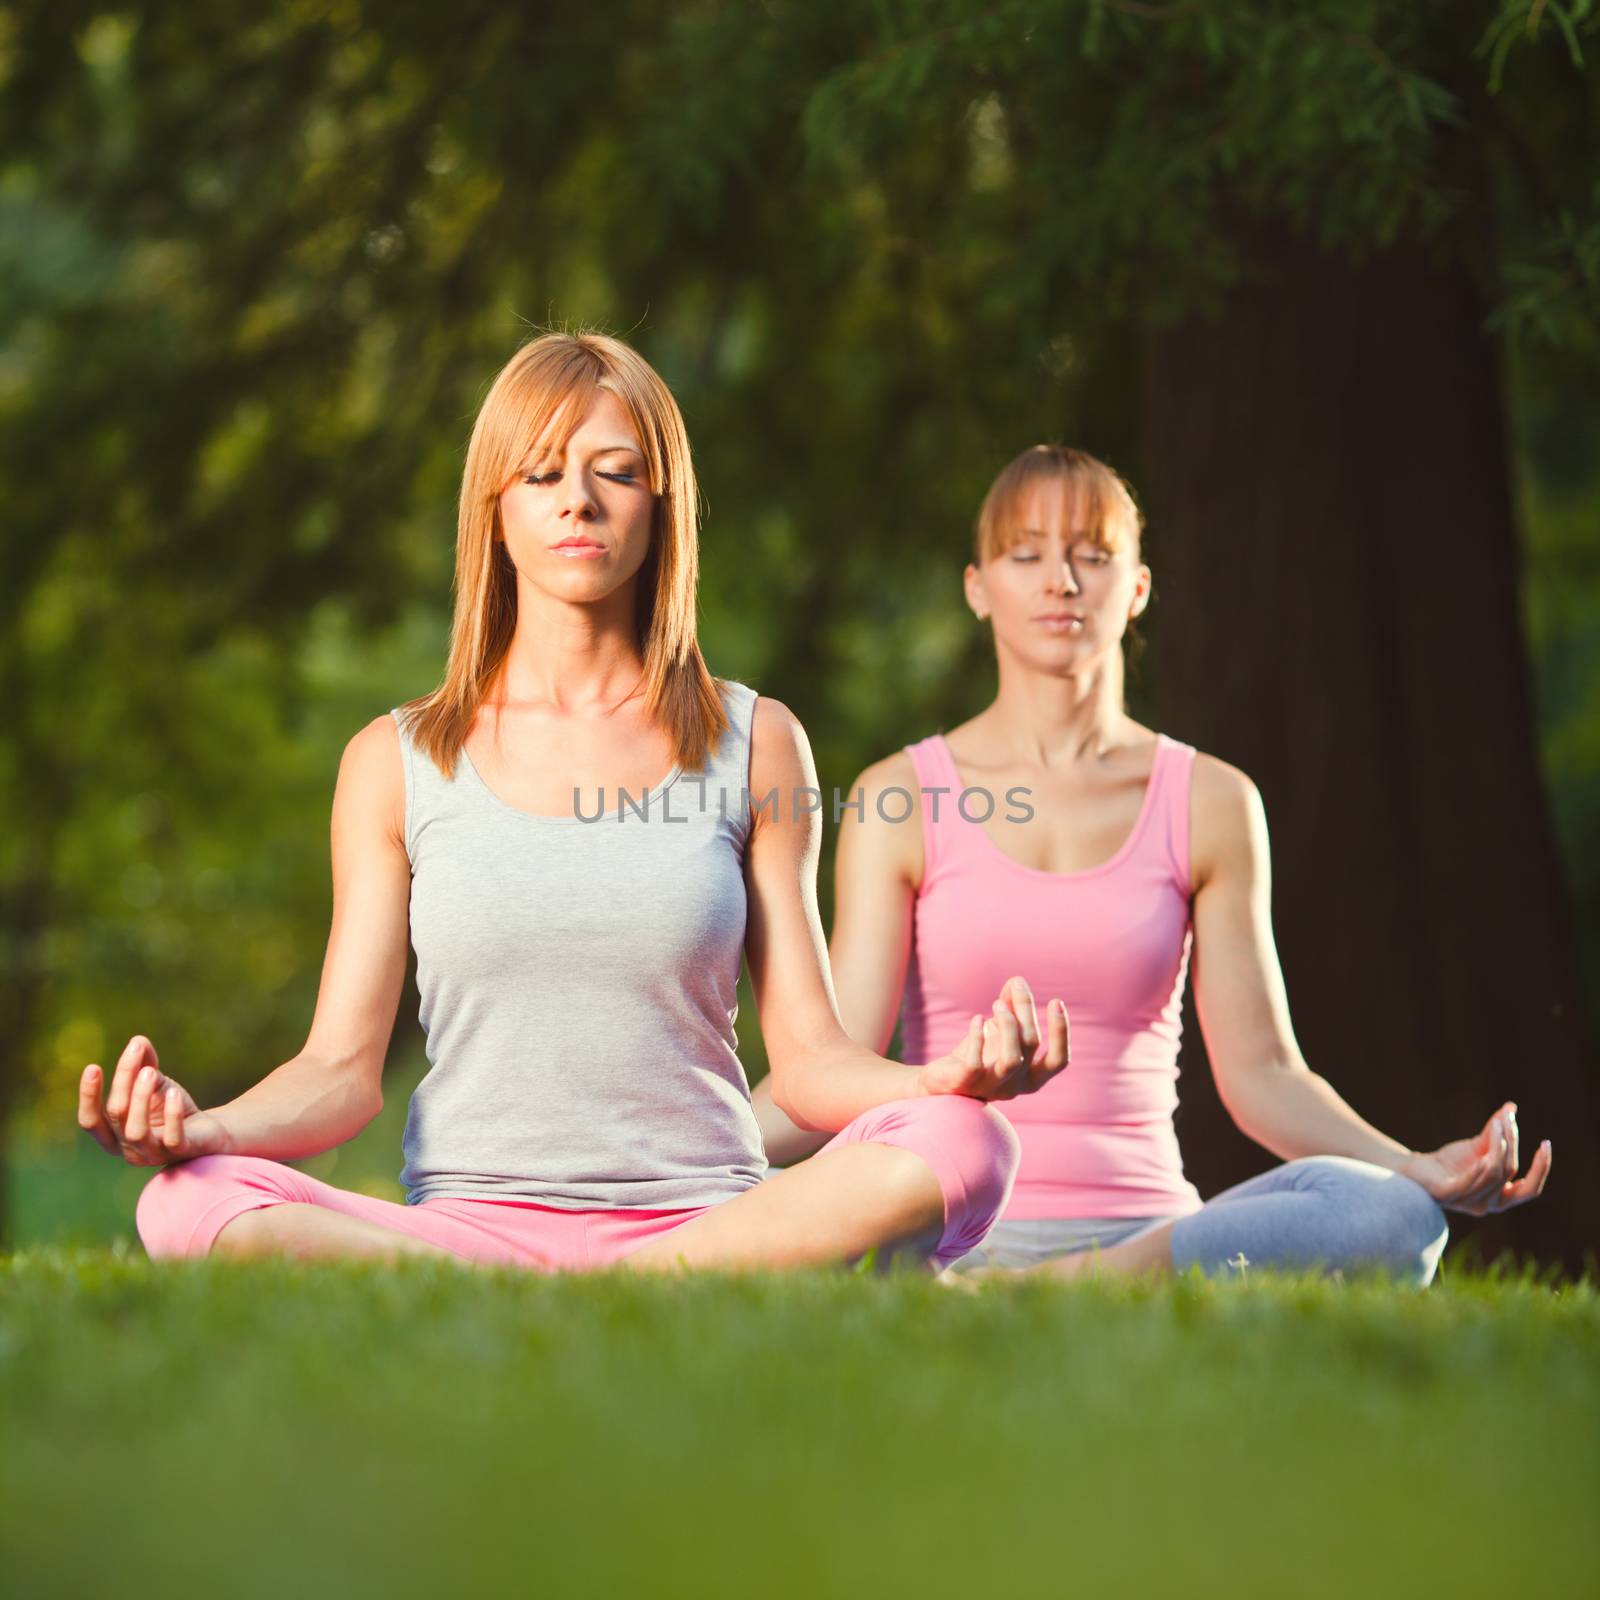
[{"left": 1144, "top": 222, "right": 1600, "bottom": 1269}]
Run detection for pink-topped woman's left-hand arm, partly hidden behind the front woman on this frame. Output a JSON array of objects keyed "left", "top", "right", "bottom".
[{"left": 752, "top": 750, "right": 922, "bottom": 1165}]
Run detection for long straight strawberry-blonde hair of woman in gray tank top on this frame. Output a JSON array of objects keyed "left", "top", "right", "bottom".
[{"left": 402, "top": 330, "right": 728, "bottom": 778}]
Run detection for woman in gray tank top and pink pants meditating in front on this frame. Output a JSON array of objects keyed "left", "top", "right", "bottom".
[{"left": 78, "top": 334, "right": 1067, "bottom": 1269}]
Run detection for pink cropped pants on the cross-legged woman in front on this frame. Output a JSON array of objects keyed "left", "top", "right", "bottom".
[{"left": 138, "top": 1094, "right": 1018, "bottom": 1272}]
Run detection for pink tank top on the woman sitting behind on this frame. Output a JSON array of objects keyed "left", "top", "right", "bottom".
[{"left": 901, "top": 733, "right": 1200, "bottom": 1219}]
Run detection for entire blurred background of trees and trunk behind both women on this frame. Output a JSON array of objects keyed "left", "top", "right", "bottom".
[{"left": 0, "top": 0, "right": 1600, "bottom": 1266}]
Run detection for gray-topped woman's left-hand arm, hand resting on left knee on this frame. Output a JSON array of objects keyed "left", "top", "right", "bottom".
[{"left": 78, "top": 715, "right": 411, "bottom": 1165}]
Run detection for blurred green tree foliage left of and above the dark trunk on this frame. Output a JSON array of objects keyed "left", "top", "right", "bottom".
[{"left": 0, "top": 0, "right": 1600, "bottom": 1184}]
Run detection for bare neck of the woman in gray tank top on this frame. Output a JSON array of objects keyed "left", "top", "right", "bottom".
[{"left": 488, "top": 579, "right": 645, "bottom": 712}]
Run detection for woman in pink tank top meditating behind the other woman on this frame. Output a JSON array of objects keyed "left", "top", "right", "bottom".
[{"left": 757, "top": 445, "right": 1550, "bottom": 1283}]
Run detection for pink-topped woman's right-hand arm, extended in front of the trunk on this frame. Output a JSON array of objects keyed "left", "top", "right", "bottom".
[{"left": 1190, "top": 755, "right": 1550, "bottom": 1214}]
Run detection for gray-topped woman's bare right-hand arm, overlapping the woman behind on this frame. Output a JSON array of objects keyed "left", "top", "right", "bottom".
[{"left": 746, "top": 698, "right": 1066, "bottom": 1133}]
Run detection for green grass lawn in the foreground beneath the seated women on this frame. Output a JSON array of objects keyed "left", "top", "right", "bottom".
[{"left": 0, "top": 1250, "right": 1600, "bottom": 1600}]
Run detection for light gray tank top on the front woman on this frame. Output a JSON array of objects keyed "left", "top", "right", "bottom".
[{"left": 390, "top": 682, "right": 766, "bottom": 1211}]
